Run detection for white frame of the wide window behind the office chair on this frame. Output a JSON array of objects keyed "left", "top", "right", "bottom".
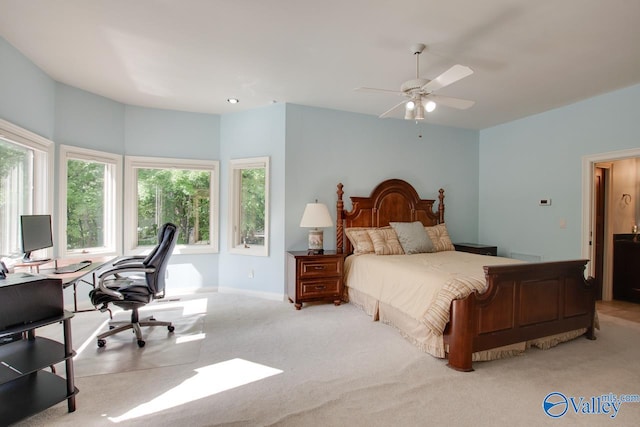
[{"left": 124, "top": 156, "right": 220, "bottom": 255}]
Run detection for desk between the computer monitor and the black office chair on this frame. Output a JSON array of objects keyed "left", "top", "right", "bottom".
[{"left": 16, "top": 255, "right": 116, "bottom": 313}]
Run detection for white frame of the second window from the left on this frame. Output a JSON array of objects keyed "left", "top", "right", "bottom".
[{"left": 57, "top": 144, "right": 122, "bottom": 258}]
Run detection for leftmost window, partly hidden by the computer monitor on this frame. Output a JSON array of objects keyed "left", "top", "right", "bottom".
[{"left": 0, "top": 120, "right": 54, "bottom": 258}]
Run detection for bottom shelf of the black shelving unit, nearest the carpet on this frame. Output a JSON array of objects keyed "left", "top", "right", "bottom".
[{"left": 0, "top": 371, "right": 78, "bottom": 425}]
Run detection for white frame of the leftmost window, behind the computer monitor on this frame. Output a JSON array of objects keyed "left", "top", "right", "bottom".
[{"left": 0, "top": 119, "right": 56, "bottom": 258}]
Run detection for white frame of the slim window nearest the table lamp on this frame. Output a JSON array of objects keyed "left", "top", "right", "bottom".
[{"left": 227, "top": 156, "right": 271, "bottom": 257}]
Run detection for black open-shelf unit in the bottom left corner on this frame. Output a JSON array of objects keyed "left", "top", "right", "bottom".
[{"left": 0, "top": 311, "right": 78, "bottom": 425}]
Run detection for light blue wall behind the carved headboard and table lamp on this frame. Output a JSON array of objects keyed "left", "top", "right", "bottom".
[{"left": 285, "top": 104, "right": 478, "bottom": 250}]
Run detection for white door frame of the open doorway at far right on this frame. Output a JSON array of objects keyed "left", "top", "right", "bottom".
[{"left": 581, "top": 148, "right": 640, "bottom": 301}]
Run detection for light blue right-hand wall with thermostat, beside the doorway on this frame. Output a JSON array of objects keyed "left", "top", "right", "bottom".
[{"left": 479, "top": 85, "right": 640, "bottom": 260}]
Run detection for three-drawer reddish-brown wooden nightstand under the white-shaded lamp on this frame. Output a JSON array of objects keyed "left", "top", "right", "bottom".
[{"left": 287, "top": 251, "right": 346, "bottom": 310}]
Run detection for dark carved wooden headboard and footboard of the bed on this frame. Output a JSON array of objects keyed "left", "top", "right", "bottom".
[{"left": 336, "top": 179, "right": 595, "bottom": 371}]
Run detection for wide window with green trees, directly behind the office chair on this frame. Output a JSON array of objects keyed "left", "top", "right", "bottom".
[{"left": 125, "top": 156, "right": 219, "bottom": 253}]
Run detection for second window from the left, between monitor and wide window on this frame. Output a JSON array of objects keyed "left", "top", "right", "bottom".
[{"left": 58, "top": 145, "right": 122, "bottom": 256}]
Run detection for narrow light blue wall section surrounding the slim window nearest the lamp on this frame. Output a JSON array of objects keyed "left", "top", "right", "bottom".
[{"left": 219, "top": 104, "right": 288, "bottom": 298}]
